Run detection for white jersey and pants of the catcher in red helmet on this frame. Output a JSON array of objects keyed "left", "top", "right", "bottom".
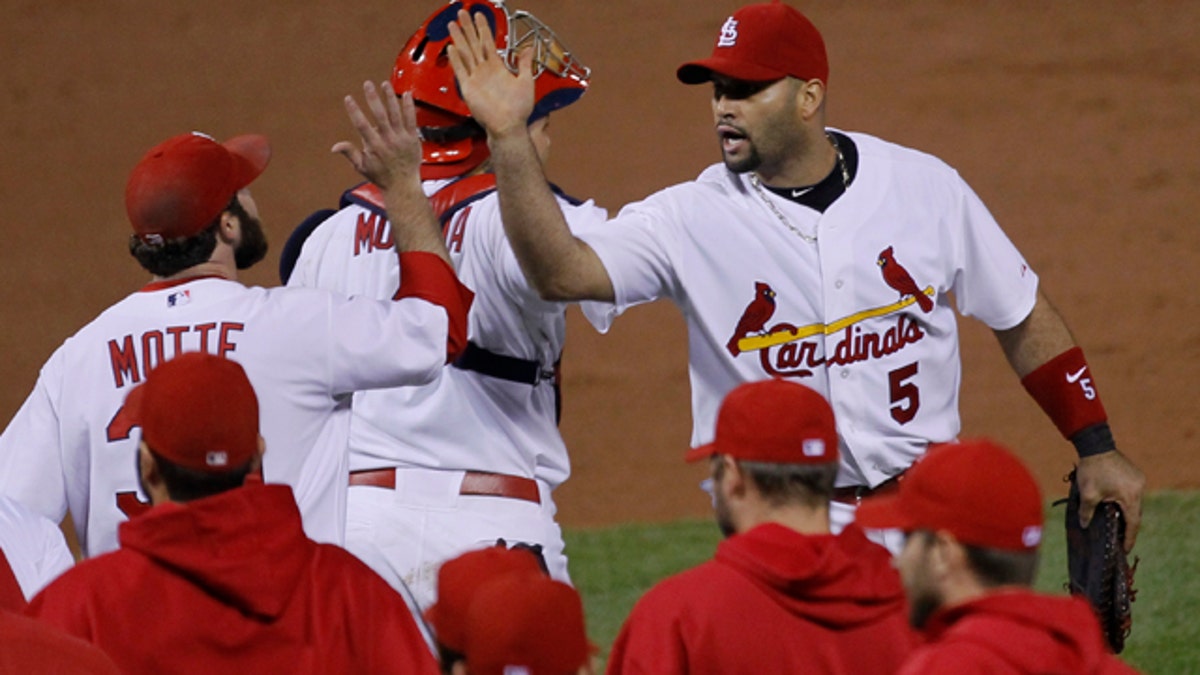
[{"left": 288, "top": 178, "right": 607, "bottom": 605}]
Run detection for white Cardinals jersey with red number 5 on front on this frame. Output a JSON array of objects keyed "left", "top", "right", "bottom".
[{"left": 582, "top": 133, "right": 1037, "bottom": 485}]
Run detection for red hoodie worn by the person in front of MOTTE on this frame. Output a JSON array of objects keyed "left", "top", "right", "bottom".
[{"left": 29, "top": 484, "right": 438, "bottom": 674}]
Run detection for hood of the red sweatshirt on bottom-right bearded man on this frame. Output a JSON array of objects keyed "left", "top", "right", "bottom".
[{"left": 925, "top": 589, "right": 1110, "bottom": 674}]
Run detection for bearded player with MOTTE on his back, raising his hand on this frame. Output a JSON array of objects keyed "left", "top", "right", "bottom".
[{"left": 0, "top": 85, "right": 470, "bottom": 555}]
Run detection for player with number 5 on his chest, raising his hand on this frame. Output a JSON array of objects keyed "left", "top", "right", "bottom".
[{"left": 441, "top": 2, "right": 1145, "bottom": 546}]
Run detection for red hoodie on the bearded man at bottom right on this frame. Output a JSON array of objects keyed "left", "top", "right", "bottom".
[{"left": 901, "top": 590, "right": 1136, "bottom": 675}]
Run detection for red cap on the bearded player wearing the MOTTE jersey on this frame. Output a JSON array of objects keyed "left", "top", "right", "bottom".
[{"left": 125, "top": 131, "right": 271, "bottom": 243}]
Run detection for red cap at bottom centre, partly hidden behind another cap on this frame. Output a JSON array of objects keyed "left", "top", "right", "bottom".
[{"left": 425, "top": 546, "right": 542, "bottom": 651}]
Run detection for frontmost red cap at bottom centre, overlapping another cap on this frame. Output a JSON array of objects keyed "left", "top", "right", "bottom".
[{"left": 463, "top": 574, "right": 595, "bottom": 675}]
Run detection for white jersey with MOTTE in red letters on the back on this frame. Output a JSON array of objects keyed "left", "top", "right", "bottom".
[{"left": 0, "top": 270, "right": 448, "bottom": 555}]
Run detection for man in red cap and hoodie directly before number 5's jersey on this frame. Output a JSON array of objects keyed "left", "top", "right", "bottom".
[{"left": 607, "top": 378, "right": 918, "bottom": 675}]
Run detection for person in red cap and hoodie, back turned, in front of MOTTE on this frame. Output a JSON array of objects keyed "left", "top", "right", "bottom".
[{"left": 29, "top": 352, "right": 438, "bottom": 675}]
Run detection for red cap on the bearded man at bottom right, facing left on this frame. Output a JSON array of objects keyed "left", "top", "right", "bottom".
[{"left": 854, "top": 438, "right": 1043, "bottom": 551}]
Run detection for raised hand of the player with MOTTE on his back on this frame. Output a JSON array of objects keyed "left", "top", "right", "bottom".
[{"left": 332, "top": 82, "right": 421, "bottom": 192}]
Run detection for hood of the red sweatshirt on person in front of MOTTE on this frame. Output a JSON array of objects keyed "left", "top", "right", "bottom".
[{"left": 120, "top": 483, "right": 317, "bottom": 619}]
